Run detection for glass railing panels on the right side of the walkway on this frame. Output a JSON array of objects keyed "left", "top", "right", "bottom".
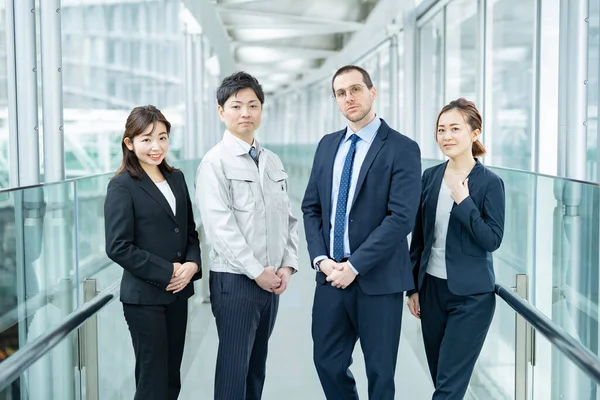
[{"left": 266, "top": 145, "right": 600, "bottom": 400}]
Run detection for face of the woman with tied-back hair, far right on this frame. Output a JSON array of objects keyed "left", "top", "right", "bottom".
[{"left": 436, "top": 110, "right": 479, "bottom": 158}]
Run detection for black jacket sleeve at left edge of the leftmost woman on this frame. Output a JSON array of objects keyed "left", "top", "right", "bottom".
[{"left": 104, "top": 179, "right": 173, "bottom": 289}]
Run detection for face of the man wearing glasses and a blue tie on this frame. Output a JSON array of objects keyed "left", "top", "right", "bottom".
[{"left": 333, "top": 70, "right": 377, "bottom": 122}]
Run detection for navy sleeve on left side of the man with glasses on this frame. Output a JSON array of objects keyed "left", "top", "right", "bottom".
[{"left": 302, "top": 139, "right": 327, "bottom": 269}]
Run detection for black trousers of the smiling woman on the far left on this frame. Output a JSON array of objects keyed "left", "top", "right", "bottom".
[{"left": 123, "top": 298, "right": 188, "bottom": 400}]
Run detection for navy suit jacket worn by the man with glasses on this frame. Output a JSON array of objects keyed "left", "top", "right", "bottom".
[{"left": 302, "top": 120, "right": 421, "bottom": 295}]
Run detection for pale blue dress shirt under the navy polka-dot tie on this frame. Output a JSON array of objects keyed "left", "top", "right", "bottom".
[{"left": 313, "top": 116, "right": 381, "bottom": 274}]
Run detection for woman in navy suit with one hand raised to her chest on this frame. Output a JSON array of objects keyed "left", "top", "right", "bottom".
[{"left": 408, "top": 98, "right": 504, "bottom": 400}]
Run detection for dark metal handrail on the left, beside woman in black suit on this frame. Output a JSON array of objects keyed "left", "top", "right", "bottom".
[{"left": 0, "top": 280, "right": 121, "bottom": 392}]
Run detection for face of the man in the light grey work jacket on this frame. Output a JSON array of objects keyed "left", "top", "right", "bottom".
[{"left": 218, "top": 88, "right": 262, "bottom": 137}]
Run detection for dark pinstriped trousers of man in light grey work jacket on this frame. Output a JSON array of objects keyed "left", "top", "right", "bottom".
[{"left": 210, "top": 271, "right": 279, "bottom": 400}]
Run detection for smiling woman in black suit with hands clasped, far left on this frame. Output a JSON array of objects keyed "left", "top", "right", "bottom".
[{"left": 104, "top": 106, "right": 201, "bottom": 400}]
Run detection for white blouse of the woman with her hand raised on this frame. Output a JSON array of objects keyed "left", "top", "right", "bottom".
[{"left": 427, "top": 180, "right": 454, "bottom": 279}]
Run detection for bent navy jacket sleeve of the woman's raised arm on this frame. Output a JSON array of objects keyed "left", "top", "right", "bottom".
[{"left": 452, "top": 175, "right": 505, "bottom": 252}]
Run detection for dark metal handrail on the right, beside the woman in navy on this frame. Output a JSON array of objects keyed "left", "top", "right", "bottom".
[{"left": 495, "top": 284, "right": 600, "bottom": 385}]
